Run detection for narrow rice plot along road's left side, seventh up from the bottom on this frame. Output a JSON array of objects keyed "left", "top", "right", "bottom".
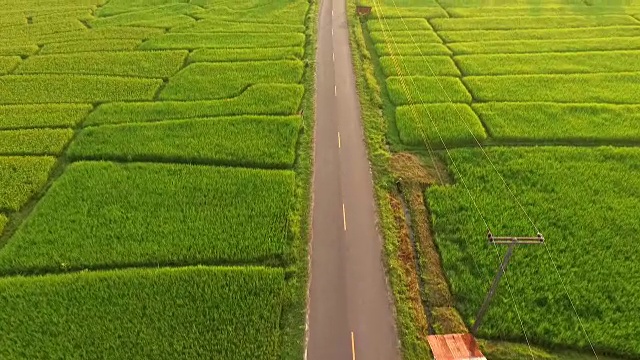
[{"left": 140, "top": 33, "right": 305, "bottom": 50}]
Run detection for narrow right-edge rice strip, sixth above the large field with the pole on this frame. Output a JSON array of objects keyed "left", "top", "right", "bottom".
[{"left": 431, "top": 15, "right": 640, "bottom": 30}]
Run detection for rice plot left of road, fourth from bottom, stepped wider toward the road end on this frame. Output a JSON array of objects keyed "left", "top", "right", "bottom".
[{"left": 84, "top": 84, "right": 304, "bottom": 126}]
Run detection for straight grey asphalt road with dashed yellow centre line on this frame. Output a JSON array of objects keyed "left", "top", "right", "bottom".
[{"left": 306, "top": 0, "right": 400, "bottom": 360}]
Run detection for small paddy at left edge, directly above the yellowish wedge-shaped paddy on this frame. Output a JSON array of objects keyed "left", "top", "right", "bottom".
[{"left": 0, "top": 129, "right": 73, "bottom": 155}]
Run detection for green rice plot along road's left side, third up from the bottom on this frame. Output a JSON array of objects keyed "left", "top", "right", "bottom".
[{"left": 69, "top": 116, "right": 301, "bottom": 168}]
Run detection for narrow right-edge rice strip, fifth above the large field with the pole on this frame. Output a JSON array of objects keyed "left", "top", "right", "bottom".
[{"left": 438, "top": 26, "right": 640, "bottom": 43}]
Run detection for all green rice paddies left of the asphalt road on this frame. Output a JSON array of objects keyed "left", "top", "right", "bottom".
[{"left": 0, "top": 0, "right": 314, "bottom": 360}]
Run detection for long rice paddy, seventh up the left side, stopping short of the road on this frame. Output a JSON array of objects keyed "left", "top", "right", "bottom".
[{"left": 15, "top": 51, "right": 189, "bottom": 78}]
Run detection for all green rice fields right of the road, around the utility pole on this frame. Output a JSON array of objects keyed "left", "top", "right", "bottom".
[{"left": 358, "top": 0, "right": 640, "bottom": 360}]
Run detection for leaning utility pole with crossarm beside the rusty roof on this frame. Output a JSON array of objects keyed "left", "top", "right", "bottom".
[{"left": 471, "top": 231, "right": 544, "bottom": 335}]
